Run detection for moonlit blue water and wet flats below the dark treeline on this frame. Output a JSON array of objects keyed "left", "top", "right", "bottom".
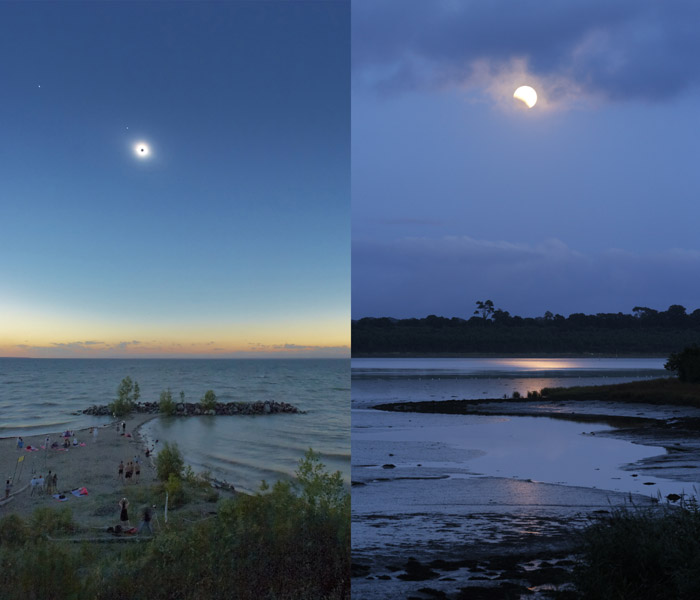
[{"left": 352, "top": 359, "right": 688, "bottom": 598}]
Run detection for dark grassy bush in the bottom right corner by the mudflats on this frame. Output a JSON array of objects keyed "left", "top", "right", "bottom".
[{"left": 575, "top": 500, "right": 700, "bottom": 600}]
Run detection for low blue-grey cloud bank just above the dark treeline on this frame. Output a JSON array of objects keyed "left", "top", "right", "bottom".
[{"left": 352, "top": 237, "right": 700, "bottom": 318}]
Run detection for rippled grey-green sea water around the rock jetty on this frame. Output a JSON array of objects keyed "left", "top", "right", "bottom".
[{"left": 0, "top": 358, "right": 350, "bottom": 491}]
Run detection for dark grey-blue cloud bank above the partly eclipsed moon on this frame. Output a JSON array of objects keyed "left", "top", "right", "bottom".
[{"left": 352, "top": 0, "right": 700, "bottom": 101}]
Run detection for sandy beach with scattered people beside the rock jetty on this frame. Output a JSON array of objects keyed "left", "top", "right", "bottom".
[{"left": 0, "top": 414, "right": 160, "bottom": 528}]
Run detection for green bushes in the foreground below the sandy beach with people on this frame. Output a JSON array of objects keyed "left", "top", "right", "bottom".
[{"left": 0, "top": 447, "right": 350, "bottom": 600}]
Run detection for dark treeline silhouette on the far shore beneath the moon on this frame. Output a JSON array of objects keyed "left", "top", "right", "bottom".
[{"left": 352, "top": 300, "right": 700, "bottom": 357}]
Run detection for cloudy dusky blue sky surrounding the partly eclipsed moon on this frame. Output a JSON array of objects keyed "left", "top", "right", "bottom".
[{"left": 352, "top": 0, "right": 700, "bottom": 318}]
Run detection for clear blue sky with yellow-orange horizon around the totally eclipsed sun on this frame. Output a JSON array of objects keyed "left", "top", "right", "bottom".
[{"left": 0, "top": 2, "right": 350, "bottom": 356}]
